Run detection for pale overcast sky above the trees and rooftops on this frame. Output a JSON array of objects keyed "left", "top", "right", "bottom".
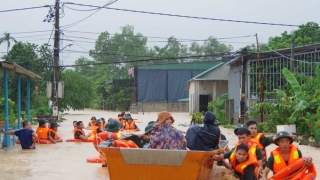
[{"left": 0, "top": 0, "right": 320, "bottom": 65}]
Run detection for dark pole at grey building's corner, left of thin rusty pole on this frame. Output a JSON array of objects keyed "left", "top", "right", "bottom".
[{"left": 240, "top": 48, "right": 248, "bottom": 124}]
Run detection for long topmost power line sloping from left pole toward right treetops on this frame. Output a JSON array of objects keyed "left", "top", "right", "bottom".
[{"left": 65, "top": 2, "right": 301, "bottom": 27}]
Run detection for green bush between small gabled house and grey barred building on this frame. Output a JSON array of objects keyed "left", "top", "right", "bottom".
[{"left": 208, "top": 93, "right": 230, "bottom": 124}]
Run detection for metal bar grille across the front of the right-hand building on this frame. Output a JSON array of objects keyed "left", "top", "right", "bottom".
[{"left": 246, "top": 50, "right": 320, "bottom": 107}]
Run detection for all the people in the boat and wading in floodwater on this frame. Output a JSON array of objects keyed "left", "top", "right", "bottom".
[{"left": 4, "top": 111, "right": 314, "bottom": 180}]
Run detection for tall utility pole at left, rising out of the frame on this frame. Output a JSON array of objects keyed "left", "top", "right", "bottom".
[{"left": 52, "top": 0, "right": 60, "bottom": 119}]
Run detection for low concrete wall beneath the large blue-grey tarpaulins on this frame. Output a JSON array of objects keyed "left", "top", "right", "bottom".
[{"left": 139, "top": 102, "right": 189, "bottom": 112}]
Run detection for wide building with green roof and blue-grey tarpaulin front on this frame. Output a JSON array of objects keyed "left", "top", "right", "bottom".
[{"left": 134, "top": 61, "right": 221, "bottom": 112}]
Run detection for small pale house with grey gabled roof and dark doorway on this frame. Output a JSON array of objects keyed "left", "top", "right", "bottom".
[{"left": 186, "top": 62, "right": 229, "bottom": 113}]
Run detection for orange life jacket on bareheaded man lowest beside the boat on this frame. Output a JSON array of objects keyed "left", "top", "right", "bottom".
[{"left": 229, "top": 145, "right": 258, "bottom": 177}]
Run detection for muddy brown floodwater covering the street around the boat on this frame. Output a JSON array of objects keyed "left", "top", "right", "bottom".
[{"left": 0, "top": 109, "right": 320, "bottom": 180}]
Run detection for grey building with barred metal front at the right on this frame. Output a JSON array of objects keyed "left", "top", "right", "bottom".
[{"left": 228, "top": 44, "right": 320, "bottom": 124}]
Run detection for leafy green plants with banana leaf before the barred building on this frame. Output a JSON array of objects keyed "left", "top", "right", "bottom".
[{"left": 249, "top": 69, "right": 320, "bottom": 137}]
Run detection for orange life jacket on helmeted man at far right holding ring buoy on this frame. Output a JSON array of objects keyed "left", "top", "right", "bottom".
[{"left": 271, "top": 144, "right": 299, "bottom": 174}]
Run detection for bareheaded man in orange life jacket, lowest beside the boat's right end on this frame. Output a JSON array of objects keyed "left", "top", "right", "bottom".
[{"left": 224, "top": 144, "right": 258, "bottom": 180}]
